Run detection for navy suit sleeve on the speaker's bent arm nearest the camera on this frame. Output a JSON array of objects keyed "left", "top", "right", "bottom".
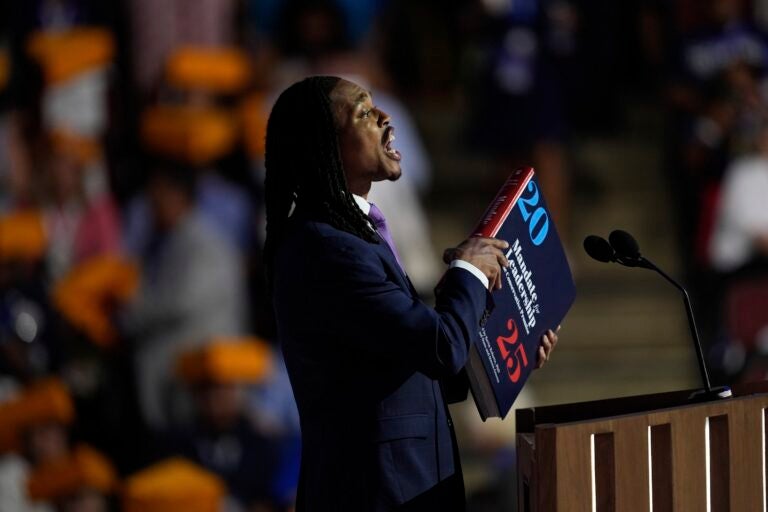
[{"left": 316, "top": 237, "right": 488, "bottom": 378}]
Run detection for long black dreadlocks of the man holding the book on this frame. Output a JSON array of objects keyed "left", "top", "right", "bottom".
[{"left": 264, "top": 76, "right": 378, "bottom": 280}]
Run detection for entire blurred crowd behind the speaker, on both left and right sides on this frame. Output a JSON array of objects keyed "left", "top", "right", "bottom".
[{"left": 0, "top": 0, "right": 768, "bottom": 512}]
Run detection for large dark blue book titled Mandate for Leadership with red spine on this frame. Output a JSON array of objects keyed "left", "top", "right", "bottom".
[{"left": 466, "top": 167, "right": 576, "bottom": 421}]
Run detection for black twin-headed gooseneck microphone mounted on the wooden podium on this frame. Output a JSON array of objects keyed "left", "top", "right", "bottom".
[{"left": 584, "top": 229, "right": 732, "bottom": 400}]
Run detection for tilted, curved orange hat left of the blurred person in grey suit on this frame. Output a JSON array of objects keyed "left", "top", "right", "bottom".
[{"left": 52, "top": 255, "right": 139, "bottom": 346}]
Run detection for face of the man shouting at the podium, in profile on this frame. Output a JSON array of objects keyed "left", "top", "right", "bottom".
[{"left": 331, "top": 80, "right": 401, "bottom": 196}]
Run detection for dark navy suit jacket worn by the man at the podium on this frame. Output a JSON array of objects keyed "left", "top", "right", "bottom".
[{"left": 273, "top": 215, "right": 489, "bottom": 512}]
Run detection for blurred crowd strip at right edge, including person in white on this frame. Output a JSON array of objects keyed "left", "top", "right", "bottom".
[{"left": 654, "top": 0, "right": 768, "bottom": 382}]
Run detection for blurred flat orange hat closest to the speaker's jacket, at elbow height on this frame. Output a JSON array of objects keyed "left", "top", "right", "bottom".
[{"left": 177, "top": 337, "right": 272, "bottom": 384}]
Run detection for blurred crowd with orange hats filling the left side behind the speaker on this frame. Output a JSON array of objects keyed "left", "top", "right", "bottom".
[{"left": 0, "top": 0, "right": 450, "bottom": 512}]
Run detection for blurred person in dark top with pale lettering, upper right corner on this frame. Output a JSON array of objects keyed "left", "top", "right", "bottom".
[{"left": 667, "top": 0, "right": 768, "bottom": 263}]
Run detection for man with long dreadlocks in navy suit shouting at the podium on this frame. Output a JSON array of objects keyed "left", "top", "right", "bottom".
[{"left": 265, "top": 77, "right": 557, "bottom": 512}]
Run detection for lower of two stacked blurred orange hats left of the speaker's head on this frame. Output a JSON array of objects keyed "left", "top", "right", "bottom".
[{"left": 141, "top": 105, "right": 238, "bottom": 165}]
